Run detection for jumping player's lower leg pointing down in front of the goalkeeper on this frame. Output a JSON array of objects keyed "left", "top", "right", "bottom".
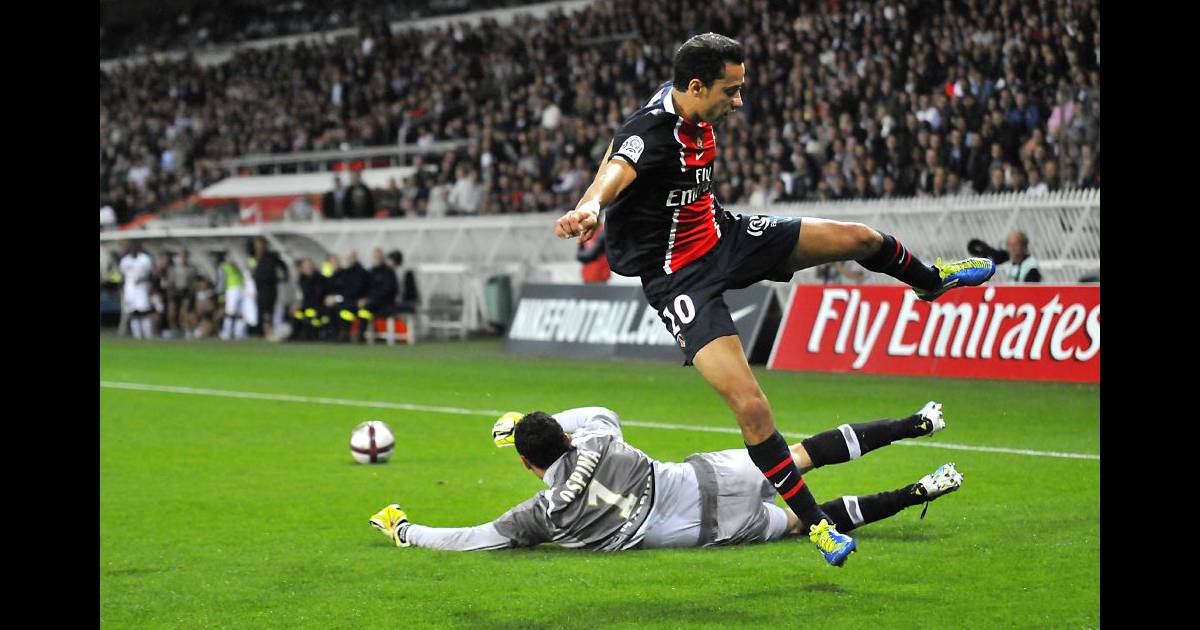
[{"left": 692, "top": 335, "right": 857, "bottom": 566}]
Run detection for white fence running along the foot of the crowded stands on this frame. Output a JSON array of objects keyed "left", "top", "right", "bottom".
[{"left": 100, "top": 190, "right": 1100, "bottom": 331}]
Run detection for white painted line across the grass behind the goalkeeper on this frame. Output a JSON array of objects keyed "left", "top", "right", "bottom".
[{"left": 100, "top": 380, "right": 1100, "bottom": 461}]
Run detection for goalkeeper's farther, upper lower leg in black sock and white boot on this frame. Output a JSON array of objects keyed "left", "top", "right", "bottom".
[{"left": 791, "top": 401, "right": 946, "bottom": 473}]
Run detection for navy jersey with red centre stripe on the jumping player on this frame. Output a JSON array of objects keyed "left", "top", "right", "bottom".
[{"left": 605, "top": 82, "right": 721, "bottom": 277}]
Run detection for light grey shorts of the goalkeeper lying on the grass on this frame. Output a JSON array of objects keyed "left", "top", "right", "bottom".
[{"left": 685, "top": 449, "right": 787, "bottom": 546}]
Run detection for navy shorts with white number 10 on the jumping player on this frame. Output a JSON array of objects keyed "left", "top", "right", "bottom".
[{"left": 642, "top": 211, "right": 800, "bottom": 365}]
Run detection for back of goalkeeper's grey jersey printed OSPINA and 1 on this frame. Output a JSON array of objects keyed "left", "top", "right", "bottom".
[{"left": 493, "top": 407, "right": 655, "bottom": 551}]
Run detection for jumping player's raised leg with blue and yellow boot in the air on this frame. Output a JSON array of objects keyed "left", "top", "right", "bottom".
[{"left": 788, "top": 217, "right": 996, "bottom": 301}]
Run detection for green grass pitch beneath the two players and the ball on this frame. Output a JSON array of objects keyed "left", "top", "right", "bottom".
[{"left": 100, "top": 336, "right": 1100, "bottom": 629}]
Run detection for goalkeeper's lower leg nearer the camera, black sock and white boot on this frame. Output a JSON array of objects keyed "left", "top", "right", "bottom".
[{"left": 787, "top": 462, "right": 962, "bottom": 535}]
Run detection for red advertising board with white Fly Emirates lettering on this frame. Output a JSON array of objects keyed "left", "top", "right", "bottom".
[{"left": 767, "top": 284, "right": 1100, "bottom": 383}]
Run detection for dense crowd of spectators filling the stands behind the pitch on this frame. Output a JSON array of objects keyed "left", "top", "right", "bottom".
[{"left": 100, "top": 0, "right": 1100, "bottom": 223}]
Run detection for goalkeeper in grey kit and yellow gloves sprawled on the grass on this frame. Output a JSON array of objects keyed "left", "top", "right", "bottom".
[{"left": 371, "top": 402, "right": 962, "bottom": 554}]
